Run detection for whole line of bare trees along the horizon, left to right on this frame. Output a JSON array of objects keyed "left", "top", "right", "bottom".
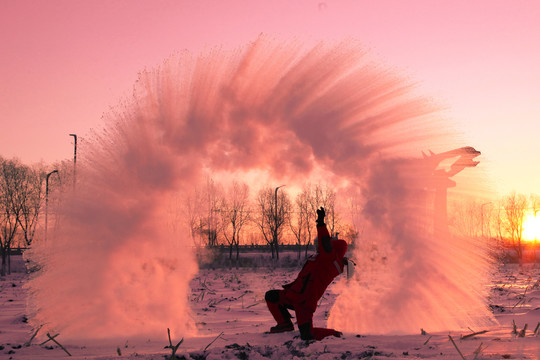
[{"left": 0, "top": 153, "right": 540, "bottom": 275}]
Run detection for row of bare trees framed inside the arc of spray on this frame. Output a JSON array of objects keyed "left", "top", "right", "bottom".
[{"left": 185, "top": 179, "right": 350, "bottom": 261}]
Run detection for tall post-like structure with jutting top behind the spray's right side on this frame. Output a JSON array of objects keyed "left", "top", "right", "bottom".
[{"left": 422, "top": 146, "right": 481, "bottom": 234}]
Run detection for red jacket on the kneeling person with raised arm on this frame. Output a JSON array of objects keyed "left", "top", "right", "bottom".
[{"left": 283, "top": 225, "right": 347, "bottom": 311}]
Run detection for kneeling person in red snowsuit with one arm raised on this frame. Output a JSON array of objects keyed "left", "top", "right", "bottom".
[{"left": 265, "top": 207, "right": 347, "bottom": 340}]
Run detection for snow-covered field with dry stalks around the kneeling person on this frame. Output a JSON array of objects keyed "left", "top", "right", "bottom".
[{"left": 0, "top": 255, "right": 540, "bottom": 360}]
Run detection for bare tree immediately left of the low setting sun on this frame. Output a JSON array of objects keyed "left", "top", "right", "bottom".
[{"left": 503, "top": 193, "right": 527, "bottom": 261}]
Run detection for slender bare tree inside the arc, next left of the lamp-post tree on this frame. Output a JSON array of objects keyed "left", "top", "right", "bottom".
[{"left": 219, "top": 181, "right": 250, "bottom": 268}]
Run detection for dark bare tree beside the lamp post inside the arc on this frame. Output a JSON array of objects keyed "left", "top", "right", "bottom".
[{"left": 255, "top": 187, "right": 291, "bottom": 259}]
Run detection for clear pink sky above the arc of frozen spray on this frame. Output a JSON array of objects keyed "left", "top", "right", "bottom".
[{"left": 0, "top": 0, "right": 540, "bottom": 194}]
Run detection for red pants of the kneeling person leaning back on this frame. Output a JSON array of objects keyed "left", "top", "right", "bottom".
[{"left": 265, "top": 290, "right": 338, "bottom": 340}]
